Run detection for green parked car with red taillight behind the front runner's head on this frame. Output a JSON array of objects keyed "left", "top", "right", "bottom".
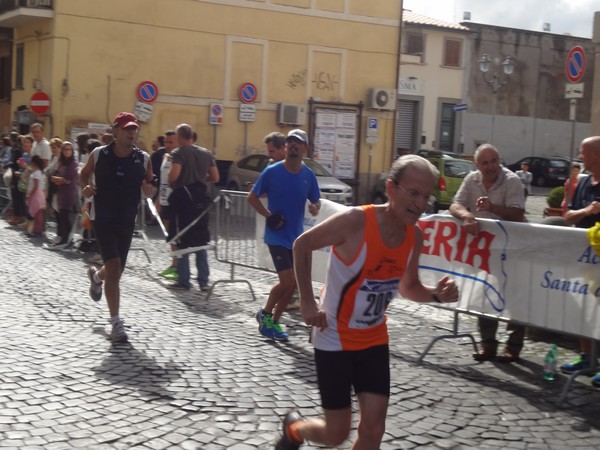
[{"left": 372, "top": 151, "right": 477, "bottom": 212}]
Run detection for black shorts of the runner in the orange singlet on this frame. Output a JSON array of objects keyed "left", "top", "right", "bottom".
[{"left": 315, "top": 345, "right": 390, "bottom": 410}]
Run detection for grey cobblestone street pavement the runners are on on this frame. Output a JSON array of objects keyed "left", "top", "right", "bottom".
[{"left": 0, "top": 192, "right": 600, "bottom": 450}]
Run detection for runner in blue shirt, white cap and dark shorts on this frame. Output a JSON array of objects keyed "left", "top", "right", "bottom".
[{"left": 248, "top": 129, "right": 321, "bottom": 341}]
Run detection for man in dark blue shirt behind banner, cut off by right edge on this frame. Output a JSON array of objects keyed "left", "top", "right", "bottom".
[{"left": 560, "top": 136, "right": 600, "bottom": 387}]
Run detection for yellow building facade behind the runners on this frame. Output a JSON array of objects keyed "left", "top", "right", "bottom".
[{"left": 0, "top": 0, "right": 402, "bottom": 200}]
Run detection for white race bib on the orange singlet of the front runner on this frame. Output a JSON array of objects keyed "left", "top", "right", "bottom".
[{"left": 348, "top": 278, "right": 400, "bottom": 329}]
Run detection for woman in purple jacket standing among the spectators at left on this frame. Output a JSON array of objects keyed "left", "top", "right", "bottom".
[{"left": 50, "top": 141, "right": 78, "bottom": 245}]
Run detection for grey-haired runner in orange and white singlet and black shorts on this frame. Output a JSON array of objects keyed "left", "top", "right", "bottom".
[{"left": 275, "top": 155, "right": 458, "bottom": 450}]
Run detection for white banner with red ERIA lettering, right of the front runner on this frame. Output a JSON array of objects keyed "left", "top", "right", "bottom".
[{"left": 419, "top": 215, "right": 600, "bottom": 339}]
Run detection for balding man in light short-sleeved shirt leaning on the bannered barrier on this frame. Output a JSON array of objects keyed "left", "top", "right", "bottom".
[{"left": 450, "top": 144, "right": 525, "bottom": 362}]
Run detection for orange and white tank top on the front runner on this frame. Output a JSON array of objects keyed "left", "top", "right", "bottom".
[{"left": 312, "top": 205, "right": 415, "bottom": 351}]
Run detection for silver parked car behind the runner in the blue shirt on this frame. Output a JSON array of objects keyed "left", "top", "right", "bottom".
[{"left": 227, "top": 154, "right": 354, "bottom": 205}]
